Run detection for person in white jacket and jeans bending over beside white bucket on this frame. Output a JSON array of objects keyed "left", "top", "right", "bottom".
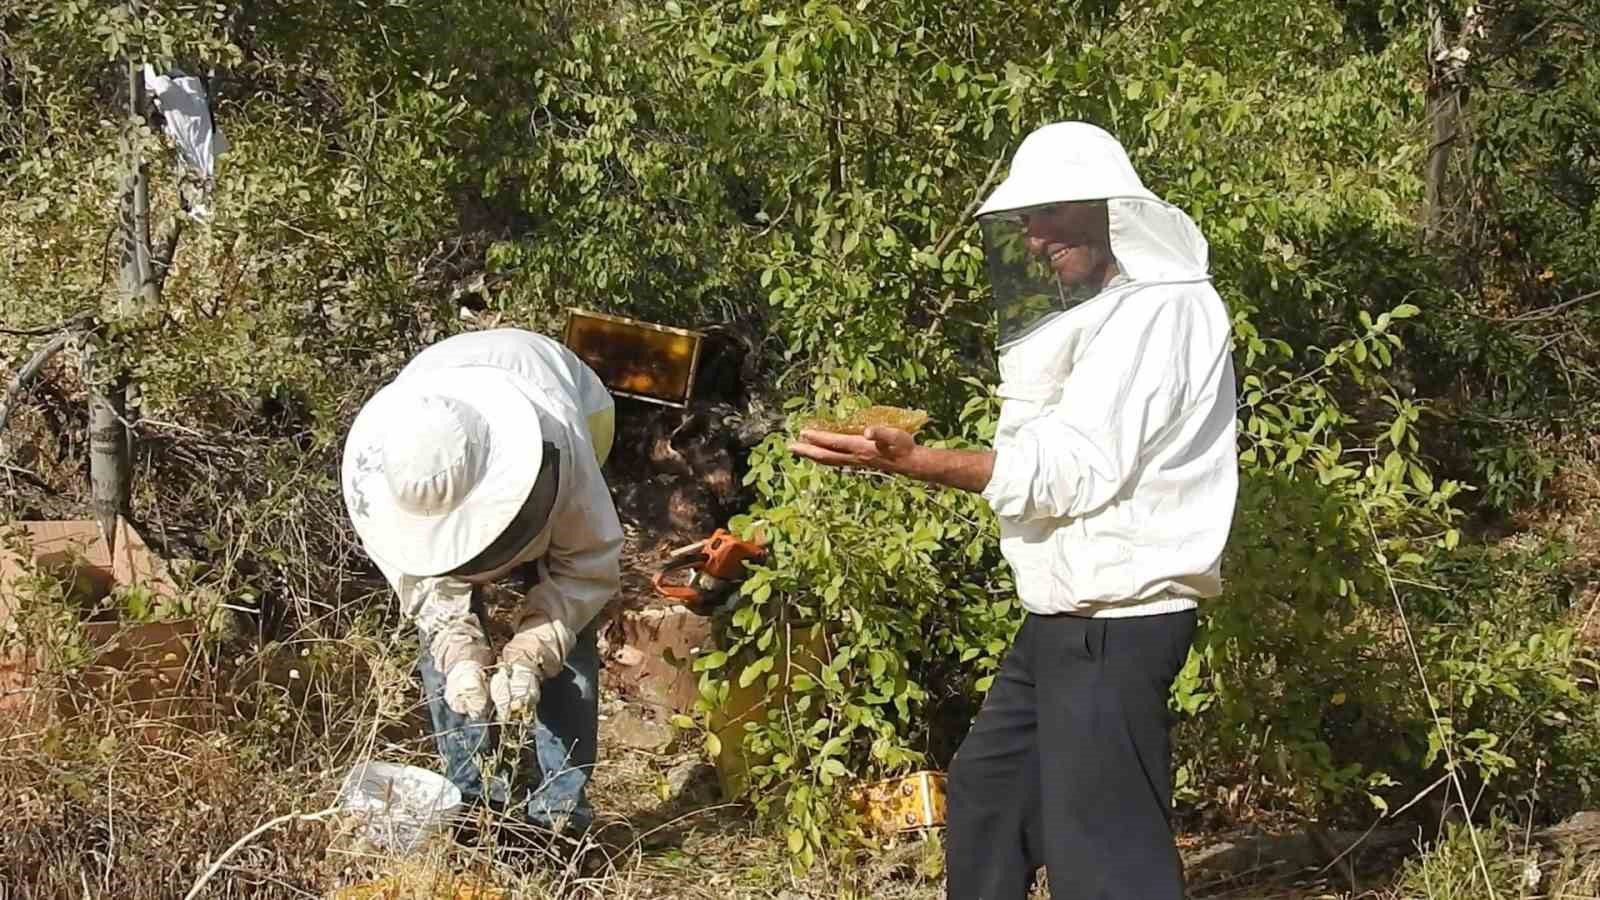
[{"left": 342, "top": 328, "right": 622, "bottom": 833}]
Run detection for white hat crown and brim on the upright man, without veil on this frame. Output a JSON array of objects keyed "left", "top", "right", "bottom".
[{"left": 976, "top": 122, "right": 1157, "bottom": 218}]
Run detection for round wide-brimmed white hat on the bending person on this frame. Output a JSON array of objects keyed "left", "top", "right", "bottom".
[{"left": 342, "top": 365, "right": 544, "bottom": 577}]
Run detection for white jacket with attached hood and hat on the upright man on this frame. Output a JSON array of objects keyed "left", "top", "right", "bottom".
[{"left": 979, "top": 123, "right": 1238, "bottom": 617}]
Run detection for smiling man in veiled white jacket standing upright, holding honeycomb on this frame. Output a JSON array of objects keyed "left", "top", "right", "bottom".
[{"left": 794, "top": 122, "right": 1238, "bottom": 900}]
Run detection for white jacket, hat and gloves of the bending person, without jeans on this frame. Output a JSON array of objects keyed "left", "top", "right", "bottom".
[{"left": 344, "top": 328, "right": 622, "bottom": 717}]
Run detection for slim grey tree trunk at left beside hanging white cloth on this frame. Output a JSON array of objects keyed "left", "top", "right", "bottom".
[{"left": 85, "top": 2, "right": 158, "bottom": 549}]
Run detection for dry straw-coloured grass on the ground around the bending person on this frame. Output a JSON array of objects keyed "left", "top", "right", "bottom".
[{"left": 0, "top": 605, "right": 942, "bottom": 900}]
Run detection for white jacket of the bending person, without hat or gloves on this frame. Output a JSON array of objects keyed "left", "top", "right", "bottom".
[{"left": 374, "top": 328, "right": 622, "bottom": 676}]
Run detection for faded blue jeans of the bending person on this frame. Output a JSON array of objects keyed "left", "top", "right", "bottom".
[{"left": 418, "top": 596, "right": 600, "bottom": 833}]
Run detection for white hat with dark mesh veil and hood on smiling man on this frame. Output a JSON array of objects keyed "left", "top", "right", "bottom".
[{"left": 976, "top": 122, "right": 1210, "bottom": 348}]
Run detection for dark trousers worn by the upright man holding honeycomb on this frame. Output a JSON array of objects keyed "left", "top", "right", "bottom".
[{"left": 946, "top": 610, "right": 1195, "bottom": 900}]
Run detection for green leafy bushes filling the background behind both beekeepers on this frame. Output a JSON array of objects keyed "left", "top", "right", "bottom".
[{"left": 0, "top": 0, "right": 1600, "bottom": 858}]
